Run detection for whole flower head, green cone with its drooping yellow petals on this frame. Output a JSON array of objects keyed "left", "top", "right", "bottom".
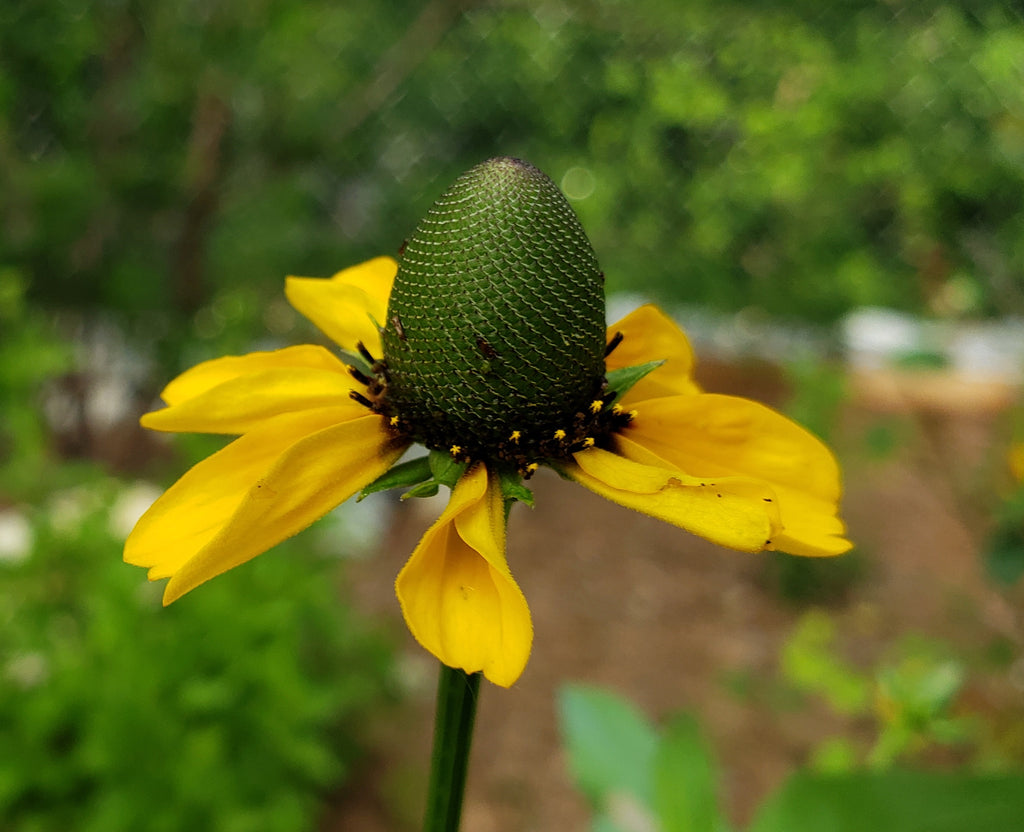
[{"left": 125, "top": 159, "right": 850, "bottom": 685}]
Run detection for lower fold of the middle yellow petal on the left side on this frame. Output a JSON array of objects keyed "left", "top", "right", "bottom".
[{"left": 141, "top": 362, "right": 369, "bottom": 433}]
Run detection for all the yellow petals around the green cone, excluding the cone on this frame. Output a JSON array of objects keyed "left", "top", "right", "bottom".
[{"left": 125, "top": 257, "right": 850, "bottom": 687}]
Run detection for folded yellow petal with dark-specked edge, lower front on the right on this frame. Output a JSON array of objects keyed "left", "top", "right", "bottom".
[{"left": 565, "top": 440, "right": 777, "bottom": 552}]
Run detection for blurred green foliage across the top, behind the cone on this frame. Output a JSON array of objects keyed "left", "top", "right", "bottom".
[{"left": 0, "top": 0, "right": 1024, "bottom": 350}]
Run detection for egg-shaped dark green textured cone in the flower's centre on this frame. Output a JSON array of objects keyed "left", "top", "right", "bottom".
[{"left": 382, "top": 158, "right": 605, "bottom": 471}]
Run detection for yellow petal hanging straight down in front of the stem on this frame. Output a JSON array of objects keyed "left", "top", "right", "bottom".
[{"left": 395, "top": 463, "right": 534, "bottom": 688}]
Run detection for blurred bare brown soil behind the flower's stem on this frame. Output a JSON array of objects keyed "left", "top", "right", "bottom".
[{"left": 324, "top": 367, "right": 1024, "bottom": 832}]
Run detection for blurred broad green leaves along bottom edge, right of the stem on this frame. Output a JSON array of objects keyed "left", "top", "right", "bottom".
[{"left": 559, "top": 685, "right": 1024, "bottom": 832}]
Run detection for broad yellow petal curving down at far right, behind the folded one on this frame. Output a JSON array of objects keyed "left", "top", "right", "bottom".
[{"left": 623, "top": 393, "right": 852, "bottom": 556}]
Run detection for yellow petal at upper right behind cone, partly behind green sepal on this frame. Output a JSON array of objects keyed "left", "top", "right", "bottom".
[{"left": 605, "top": 303, "right": 700, "bottom": 404}]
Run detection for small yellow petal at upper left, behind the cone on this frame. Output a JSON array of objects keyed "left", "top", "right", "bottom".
[{"left": 285, "top": 257, "right": 398, "bottom": 357}]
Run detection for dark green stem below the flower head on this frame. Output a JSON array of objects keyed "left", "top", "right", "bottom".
[{"left": 423, "top": 664, "right": 480, "bottom": 832}]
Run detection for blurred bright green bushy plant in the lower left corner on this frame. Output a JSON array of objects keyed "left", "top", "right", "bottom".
[{"left": 0, "top": 477, "right": 390, "bottom": 832}]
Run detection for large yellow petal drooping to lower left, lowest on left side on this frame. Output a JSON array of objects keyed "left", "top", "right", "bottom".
[{"left": 125, "top": 408, "right": 406, "bottom": 604}]
